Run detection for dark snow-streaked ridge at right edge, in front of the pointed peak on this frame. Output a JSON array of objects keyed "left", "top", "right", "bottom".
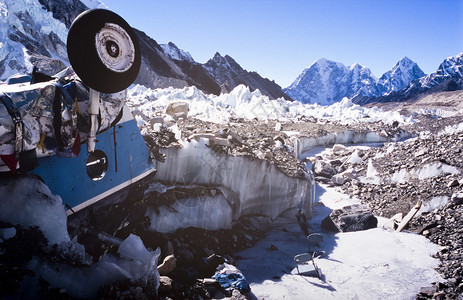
[{"left": 352, "top": 53, "right": 463, "bottom": 105}]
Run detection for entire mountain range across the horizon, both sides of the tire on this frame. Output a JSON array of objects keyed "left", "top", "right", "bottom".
[{"left": 0, "top": 0, "right": 463, "bottom": 105}]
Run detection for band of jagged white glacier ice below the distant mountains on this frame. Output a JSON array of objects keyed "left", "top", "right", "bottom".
[{"left": 127, "top": 85, "right": 415, "bottom": 124}]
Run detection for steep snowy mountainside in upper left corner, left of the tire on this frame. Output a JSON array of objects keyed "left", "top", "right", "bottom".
[{"left": 0, "top": 0, "right": 67, "bottom": 80}]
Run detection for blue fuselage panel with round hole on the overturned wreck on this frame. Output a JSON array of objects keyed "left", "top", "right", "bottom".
[{"left": 33, "top": 119, "right": 155, "bottom": 211}]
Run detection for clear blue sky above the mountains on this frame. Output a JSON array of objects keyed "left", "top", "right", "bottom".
[{"left": 102, "top": 0, "right": 463, "bottom": 88}]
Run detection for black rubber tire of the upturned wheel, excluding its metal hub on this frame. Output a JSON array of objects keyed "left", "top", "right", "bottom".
[{"left": 67, "top": 9, "right": 141, "bottom": 93}]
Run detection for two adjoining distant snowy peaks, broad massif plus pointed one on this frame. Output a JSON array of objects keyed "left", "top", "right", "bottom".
[{"left": 284, "top": 57, "right": 425, "bottom": 105}]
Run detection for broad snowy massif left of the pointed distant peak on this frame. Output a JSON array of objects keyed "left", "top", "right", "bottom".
[{"left": 284, "top": 58, "right": 376, "bottom": 105}]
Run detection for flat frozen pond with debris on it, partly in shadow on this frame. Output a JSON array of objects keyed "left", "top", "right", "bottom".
[{"left": 237, "top": 186, "right": 441, "bottom": 299}]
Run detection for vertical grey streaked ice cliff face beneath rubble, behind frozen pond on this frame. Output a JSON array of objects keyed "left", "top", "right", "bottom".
[{"left": 156, "top": 139, "right": 312, "bottom": 224}]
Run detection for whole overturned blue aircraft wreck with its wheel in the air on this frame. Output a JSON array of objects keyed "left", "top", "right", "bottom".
[{"left": 0, "top": 9, "right": 155, "bottom": 232}]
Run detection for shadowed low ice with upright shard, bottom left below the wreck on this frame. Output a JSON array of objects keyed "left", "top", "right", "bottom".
[{"left": 27, "top": 235, "right": 160, "bottom": 299}]
